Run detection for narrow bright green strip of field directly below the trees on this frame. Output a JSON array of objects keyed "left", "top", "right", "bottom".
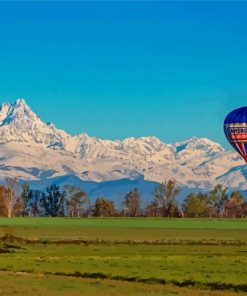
[{"left": 0, "top": 217, "right": 247, "bottom": 230}]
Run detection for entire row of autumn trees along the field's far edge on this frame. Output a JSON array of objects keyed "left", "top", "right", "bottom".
[{"left": 0, "top": 178, "right": 247, "bottom": 218}]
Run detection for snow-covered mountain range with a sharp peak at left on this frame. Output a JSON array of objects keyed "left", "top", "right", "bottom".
[{"left": 0, "top": 99, "right": 247, "bottom": 195}]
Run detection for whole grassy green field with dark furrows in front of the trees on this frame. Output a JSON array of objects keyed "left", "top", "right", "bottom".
[{"left": 0, "top": 218, "right": 247, "bottom": 295}]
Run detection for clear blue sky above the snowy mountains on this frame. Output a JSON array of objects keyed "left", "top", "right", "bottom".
[{"left": 0, "top": 2, "right": 247, "bottom": 147}]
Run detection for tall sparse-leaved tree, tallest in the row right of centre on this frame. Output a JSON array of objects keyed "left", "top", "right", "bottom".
[{"left": 153, "top": 180, "right": 180, "bottom": 217}]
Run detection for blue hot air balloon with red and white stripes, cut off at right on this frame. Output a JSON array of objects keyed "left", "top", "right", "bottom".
[{"left": 224, "top": 107, "right": 247, "bottom": 163}]
